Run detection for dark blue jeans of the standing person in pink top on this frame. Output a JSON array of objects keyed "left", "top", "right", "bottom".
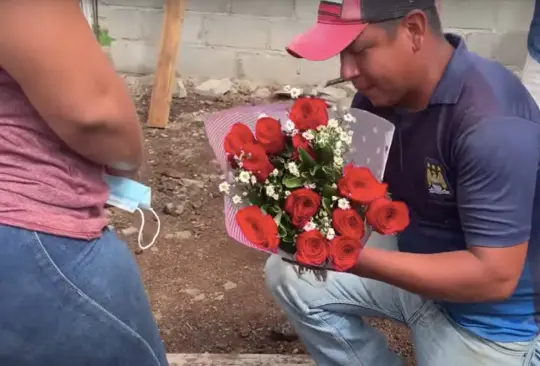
[{"left": 0, "top": 225, "right": 168, "bottom": 366}]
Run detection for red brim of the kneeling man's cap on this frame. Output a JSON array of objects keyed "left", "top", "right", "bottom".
[{"left": 286, "top": 23, "right": 368, "bottom": 61}]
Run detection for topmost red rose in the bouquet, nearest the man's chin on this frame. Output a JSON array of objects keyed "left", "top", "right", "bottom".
[{"left": 289, "top": 97, "right": 328, "bottom": 131}]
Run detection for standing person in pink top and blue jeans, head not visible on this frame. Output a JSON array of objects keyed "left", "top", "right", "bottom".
[{"left": 0, "top": 0, "right": 167, "bottom": 366}]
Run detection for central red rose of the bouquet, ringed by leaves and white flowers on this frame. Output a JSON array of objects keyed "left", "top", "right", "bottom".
[{"left": 285, "top": 188, "right": 321, "bottom": 229}]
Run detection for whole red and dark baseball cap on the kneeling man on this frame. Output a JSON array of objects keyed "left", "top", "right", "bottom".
[{"left": 286, "top": 0, "right": 435, "bottom": 61}]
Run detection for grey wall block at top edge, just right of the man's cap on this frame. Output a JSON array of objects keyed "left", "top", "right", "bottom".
[{"left": 441, "top": 0, "right": 499, "bottom": 30}]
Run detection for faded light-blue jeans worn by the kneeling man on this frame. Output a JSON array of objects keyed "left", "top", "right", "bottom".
[{"left": 266, "top": 234, "right": 535, "bottom": 366}]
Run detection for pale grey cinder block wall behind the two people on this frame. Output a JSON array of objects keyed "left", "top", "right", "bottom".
[{"left": 99, "top": 0, "right": 534, "bottom": 84}]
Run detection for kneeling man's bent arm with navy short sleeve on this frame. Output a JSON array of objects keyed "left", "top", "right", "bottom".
[{"left": 353, "top": 118, "right": 540, "bottom": 302}]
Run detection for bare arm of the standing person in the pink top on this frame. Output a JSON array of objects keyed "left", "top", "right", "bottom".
[{"left": 0, "top": 0, "right": 143, "bottom": 169}]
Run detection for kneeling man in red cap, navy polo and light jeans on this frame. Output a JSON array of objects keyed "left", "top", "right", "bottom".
[{"left": 266, "top": 0, "right": 540, "bottom": 366}]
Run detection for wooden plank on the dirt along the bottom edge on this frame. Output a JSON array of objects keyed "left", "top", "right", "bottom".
[{"left": 167, "top": 353, "right": 315, "bottom": 366}]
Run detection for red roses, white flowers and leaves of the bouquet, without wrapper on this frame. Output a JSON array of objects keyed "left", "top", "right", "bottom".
[{"left": 215, "top": 96, "right": 409, "bottom": 271}]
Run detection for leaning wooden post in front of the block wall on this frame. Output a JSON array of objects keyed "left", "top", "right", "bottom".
[{"left": 148, "top": 0, "right": 187, "bottom": 128}]
